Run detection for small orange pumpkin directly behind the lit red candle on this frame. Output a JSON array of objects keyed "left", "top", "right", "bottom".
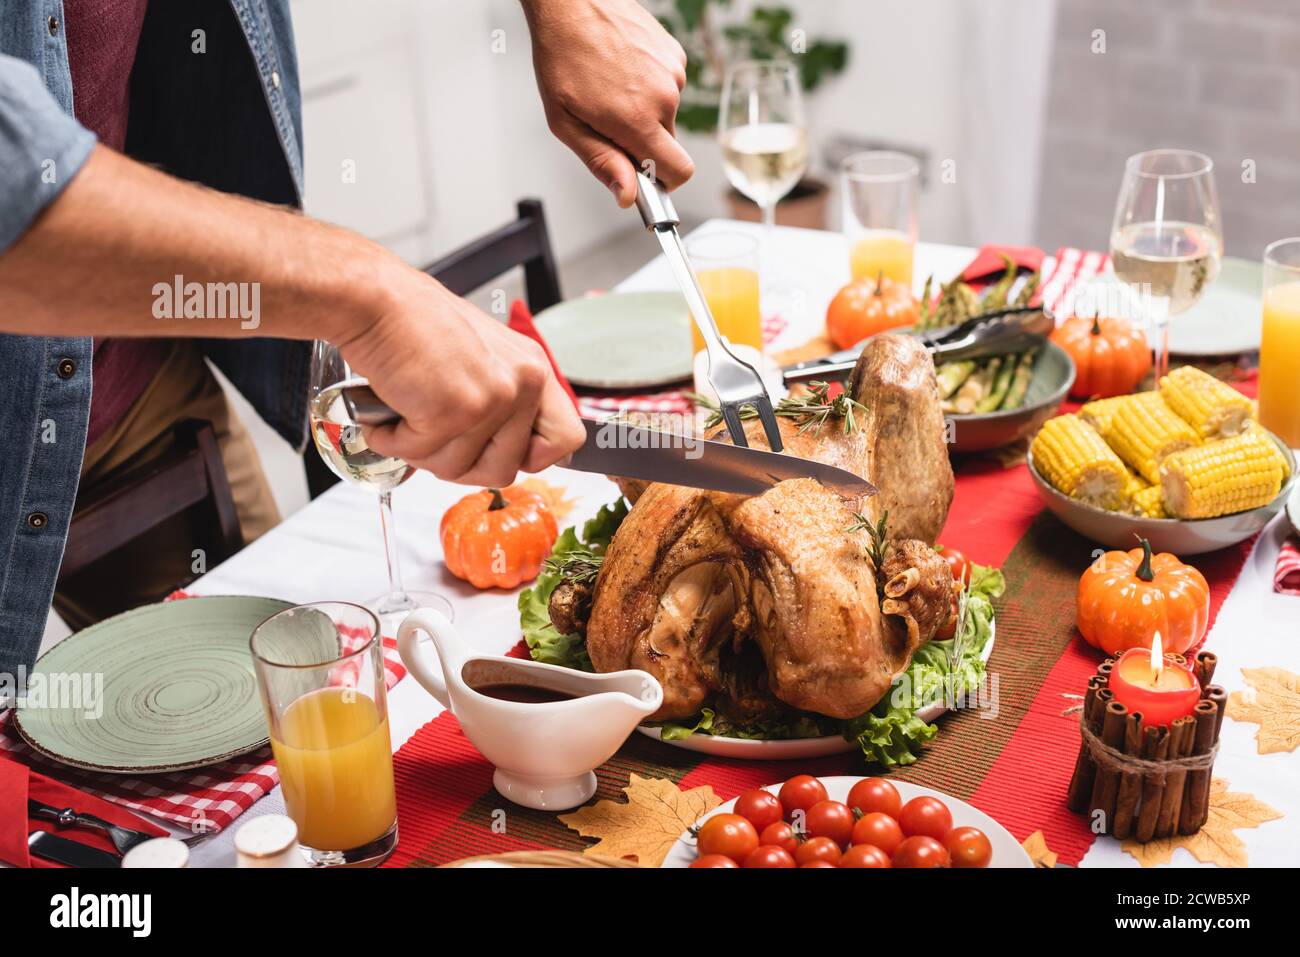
[{"left": 1076, "top": 538, "right": 1210, "bottom": 657}]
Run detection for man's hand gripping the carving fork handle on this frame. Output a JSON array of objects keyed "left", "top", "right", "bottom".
[{"left": 523, "top": 0, "right": 696, "bottom": 208}]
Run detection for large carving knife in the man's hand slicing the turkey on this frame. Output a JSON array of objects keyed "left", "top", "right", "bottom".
[{"left": 343, "top": 384, "right": 876, "bottom": 498}]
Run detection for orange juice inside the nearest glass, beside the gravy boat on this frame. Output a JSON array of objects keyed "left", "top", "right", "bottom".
[{"left": 270, "top": 688, "right": 398, "bottom": 850}]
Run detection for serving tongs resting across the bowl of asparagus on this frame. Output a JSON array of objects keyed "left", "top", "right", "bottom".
[{"left": 781, "top": 306, "right": 1056, "bottom": 382}]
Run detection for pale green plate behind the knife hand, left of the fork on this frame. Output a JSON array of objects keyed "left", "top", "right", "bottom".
[{"left": 536, "top": 293, "right": 693, "bottom": 389}]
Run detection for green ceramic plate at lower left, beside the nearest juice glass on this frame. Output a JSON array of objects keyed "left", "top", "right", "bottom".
[{"left": 14, "top": 596, "right": 290, "bottom": 774}]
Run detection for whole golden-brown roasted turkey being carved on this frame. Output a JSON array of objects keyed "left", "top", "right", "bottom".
[{"left": 551, "top": 334, "right": 953, "bottom": 719}]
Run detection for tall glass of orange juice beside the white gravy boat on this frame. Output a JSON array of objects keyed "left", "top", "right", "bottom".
[{"left": 250, "top": 602, "right": 398, "bottom": 867}]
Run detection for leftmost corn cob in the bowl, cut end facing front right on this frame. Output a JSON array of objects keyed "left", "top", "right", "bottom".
[{"left": 1030, "top": 415, "right": 1128, "bottom": 511}]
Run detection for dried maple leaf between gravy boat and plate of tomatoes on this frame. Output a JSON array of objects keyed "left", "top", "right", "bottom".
[{"left": 560, "top": 774, "right": 722, "bottom": 867}]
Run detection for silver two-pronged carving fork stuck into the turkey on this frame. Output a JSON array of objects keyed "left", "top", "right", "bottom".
[{"left": 637, "top": 170, "right": 783, "bottom": 452}]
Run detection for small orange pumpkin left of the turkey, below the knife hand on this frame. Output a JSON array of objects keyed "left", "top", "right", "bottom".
[{"left": 441, "top": 485, "right": 559, "bottom": 588}]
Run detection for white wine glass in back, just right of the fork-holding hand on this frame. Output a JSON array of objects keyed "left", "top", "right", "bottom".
[{"left": 718, "top": 60, "right": 809, "bottom": 302}]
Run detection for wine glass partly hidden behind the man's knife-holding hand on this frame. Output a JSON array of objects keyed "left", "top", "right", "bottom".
[{"left": 308, "top": 339, "right": 454, "bottom": 633}]
